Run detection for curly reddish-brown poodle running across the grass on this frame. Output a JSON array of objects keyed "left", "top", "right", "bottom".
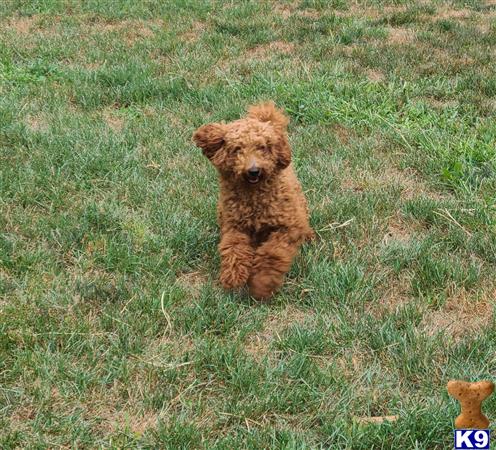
[{"left": 193, "top": 103, "right": 314, "bottom": 299}]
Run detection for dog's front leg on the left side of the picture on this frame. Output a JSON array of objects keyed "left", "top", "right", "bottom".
[{"left": 219, "top": 230, "right": 254, "bottom": 289}]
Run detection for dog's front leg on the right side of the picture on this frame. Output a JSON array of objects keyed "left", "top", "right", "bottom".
[{"left": 248, "top": 231, "right": 303, "bottom": 300}]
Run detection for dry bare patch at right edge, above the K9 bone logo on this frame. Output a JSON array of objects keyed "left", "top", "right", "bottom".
[{"left": 420, "top": 289, "right": 496, "bottom": 340}]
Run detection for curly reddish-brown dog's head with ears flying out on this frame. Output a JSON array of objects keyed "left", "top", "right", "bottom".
[{"left": 193, "top": 103, "right": 291, "bottom": 186}]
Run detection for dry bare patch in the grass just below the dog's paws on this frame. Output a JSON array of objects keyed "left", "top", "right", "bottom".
[{"left": 245, "top": 306, "right": 311, "bottom": 360}]
